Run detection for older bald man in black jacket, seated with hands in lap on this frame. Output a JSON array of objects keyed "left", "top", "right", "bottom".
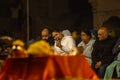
[{"left": 92, "top": 27, "right": 115, "bottom": 78}]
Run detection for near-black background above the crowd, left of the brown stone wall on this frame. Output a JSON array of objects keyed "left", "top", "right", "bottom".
[{"left": 0, "top": 0, "right": 93, "bottom": 40}]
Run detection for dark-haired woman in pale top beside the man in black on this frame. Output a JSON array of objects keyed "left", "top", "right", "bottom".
[{"left": 78, "top": 29, "right": 95, "bottom": 65}]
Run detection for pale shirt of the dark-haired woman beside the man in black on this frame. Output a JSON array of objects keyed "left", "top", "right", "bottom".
[{"left": 78, "top": 39, "right": 95, "bottom": 65}]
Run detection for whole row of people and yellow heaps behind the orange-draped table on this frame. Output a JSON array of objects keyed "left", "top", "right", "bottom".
[{"left": 0, "top": 17, "right": 120, "bottom": 78}]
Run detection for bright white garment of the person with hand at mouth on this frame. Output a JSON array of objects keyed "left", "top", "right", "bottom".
[{"left": 54, "top": 30, "right": 76, "bottom": 54}]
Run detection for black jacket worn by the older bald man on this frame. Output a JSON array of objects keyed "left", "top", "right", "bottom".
[{"left": 92, "top": 36, "right": 116, "bottom": 65}]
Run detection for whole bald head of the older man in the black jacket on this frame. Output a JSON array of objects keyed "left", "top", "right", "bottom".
[{"left": 98, "top": 27, "right": 108, "bottom": 41}]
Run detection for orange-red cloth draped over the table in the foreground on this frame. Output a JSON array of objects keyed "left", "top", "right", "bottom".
[{"left": 0, "top": 55, "right": 98, "bottom": 80}]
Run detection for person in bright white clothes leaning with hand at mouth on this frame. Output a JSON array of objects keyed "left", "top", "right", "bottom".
[{"left": 54, "top": 30, "right": 76, "bottom": 55}]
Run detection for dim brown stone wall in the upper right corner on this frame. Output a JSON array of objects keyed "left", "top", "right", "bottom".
[{"left": 89, "top": 0, "right": 120, "bottom": 28}]
